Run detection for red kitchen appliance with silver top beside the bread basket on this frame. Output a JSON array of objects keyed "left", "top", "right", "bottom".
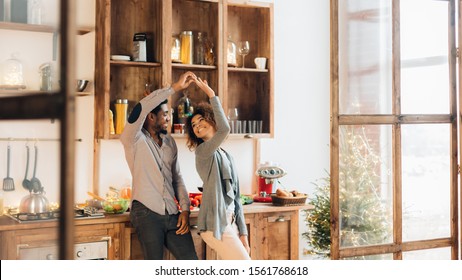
[{"left": 253, "top": 163, "right": 287, "bottom": 202}]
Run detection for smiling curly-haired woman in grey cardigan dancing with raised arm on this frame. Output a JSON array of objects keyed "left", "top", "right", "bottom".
[{"left": 186, "top": 78, "right": 250, "bottom": 260}]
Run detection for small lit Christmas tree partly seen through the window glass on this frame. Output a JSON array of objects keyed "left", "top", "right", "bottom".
[{"left": 302, "top": 127, "right": 391, "bottom": 259}]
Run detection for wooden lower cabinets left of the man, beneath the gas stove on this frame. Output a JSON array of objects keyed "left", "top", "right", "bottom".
[{"left": 0, "top": 213, "right": 129, "bottom": 260}]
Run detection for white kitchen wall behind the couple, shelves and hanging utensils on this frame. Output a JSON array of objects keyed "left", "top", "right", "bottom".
[{"left": 0, "top": 0, "right": 330, "bottom": 258}]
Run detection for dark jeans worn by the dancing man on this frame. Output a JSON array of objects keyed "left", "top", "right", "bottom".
[{"left": 130, "top": 200, "right": 197, "bottom": 260}]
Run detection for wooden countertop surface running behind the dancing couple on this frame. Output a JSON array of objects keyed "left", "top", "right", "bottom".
[{"left": 0, "top": 202, "right": 314, "bottom": 231}]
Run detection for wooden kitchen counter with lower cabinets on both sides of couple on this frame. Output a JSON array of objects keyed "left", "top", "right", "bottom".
[{"left": 0, "top": 202, "right": 313, "bottom": 260}]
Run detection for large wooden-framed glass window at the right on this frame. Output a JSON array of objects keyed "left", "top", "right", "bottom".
[{"left": 331, "top": 0, "right": 459, "bottom": 259}]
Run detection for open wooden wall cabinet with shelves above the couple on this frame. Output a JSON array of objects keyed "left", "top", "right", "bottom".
[{"left": 95, "top": 0, "right": 274, "bottom": 139}]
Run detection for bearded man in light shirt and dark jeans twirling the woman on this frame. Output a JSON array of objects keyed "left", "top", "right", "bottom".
[{"left": 120, "top": 72, "right": 197, "bottom": 260}]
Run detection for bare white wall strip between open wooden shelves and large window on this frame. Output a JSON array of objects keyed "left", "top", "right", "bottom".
[{"left": 268, "top": 0, "right": 330, "bottom": 259}]
